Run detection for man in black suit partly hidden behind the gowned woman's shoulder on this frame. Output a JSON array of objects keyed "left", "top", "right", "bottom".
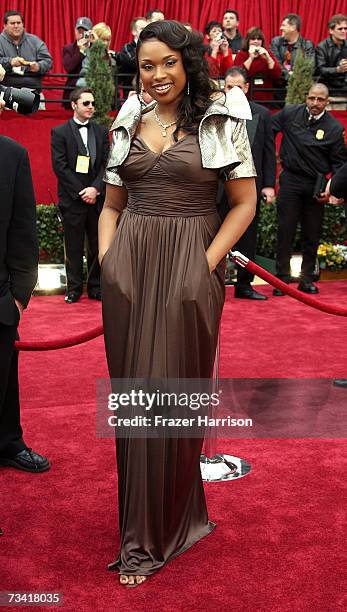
[{"left": 219, "top": 66, "right": 276, "bottom": 300}]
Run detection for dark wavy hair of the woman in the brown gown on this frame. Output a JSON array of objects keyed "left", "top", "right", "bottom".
[{"left": 136, "top": 20, "right": 219, "bottom": 140}]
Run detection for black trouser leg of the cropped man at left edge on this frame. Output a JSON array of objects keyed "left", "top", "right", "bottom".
[{"left": 0, "top": 323, "right": 26, "bottom": 457}]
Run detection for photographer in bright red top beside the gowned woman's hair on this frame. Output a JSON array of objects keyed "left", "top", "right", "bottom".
[{"left": 205, "top": 21, "right": 234, "bottom": 79}]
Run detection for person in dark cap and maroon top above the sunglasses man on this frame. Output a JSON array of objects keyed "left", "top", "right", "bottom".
[{"left": 63, "top": 17, "right": 93, "bottom": 109}]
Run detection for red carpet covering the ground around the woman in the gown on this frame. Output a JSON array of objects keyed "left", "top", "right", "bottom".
[{"left": 0, "top": 282, "right": 347, "bottom": 612}]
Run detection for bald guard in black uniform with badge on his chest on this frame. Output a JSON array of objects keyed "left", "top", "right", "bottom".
[{"left": 272, "top": 83, "right": 345, "bottom": 295}]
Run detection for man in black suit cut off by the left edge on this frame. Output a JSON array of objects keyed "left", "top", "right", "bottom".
[{"left": 0, "top": 100, "right": 50, "bottom": 472}]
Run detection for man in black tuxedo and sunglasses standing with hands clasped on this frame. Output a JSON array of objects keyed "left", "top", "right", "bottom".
[{"left": 52, "top": 87, "right": 109, "bottom": 304}]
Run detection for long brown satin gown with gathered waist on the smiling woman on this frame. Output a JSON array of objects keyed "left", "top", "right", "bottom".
[{"left": 102, "top": 135, "right": 225, "bottom": 575}]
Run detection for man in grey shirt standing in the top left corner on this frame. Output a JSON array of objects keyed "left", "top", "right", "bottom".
[{"left": 0, "top": 11, "right": 53, "bottom": 90}]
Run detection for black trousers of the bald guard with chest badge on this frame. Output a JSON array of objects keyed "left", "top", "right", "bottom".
[{"left": 276, "top": 170, "right": 324, "bottom": 282}]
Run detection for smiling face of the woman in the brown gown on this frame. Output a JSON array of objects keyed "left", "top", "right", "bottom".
[{"left": 138, "top": 38, "right": 187, "bottom": 104}]
